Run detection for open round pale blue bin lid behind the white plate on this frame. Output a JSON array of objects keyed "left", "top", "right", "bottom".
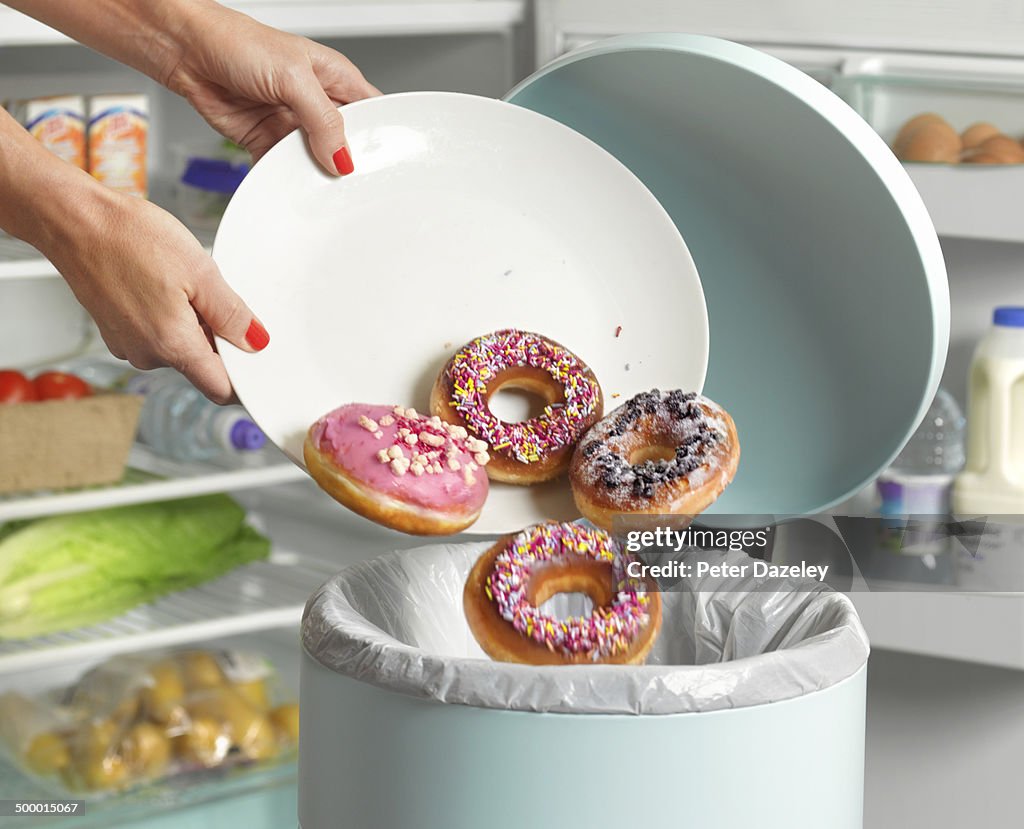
[{"left": 507, "top": 34, "right": 949, "bottom": 515}]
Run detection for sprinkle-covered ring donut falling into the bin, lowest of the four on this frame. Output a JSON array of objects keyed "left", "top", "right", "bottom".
[{"left": 463, "top": 522, "right": 662, "bottom": 665}]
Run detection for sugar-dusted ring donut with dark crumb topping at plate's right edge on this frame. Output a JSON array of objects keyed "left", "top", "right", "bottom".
[{"left": 569, "top": 389, "right": 739, "bottom": 529}]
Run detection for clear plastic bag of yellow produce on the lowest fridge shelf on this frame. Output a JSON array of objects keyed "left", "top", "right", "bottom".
[{"left": 0, "top": 649, "right": 298, "bottom": 798}]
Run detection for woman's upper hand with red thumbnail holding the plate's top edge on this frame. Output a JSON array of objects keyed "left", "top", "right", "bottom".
[{"left": 159, "top": 3, "right": 380, "bottom": 175}]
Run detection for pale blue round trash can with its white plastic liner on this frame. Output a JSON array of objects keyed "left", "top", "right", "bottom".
[{"left": 299, "top": 542, "right": 868, "bottom": 829}]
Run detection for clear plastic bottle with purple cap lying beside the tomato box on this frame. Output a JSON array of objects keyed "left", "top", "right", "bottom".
[{"left": 125, "top": 368, "right": 266, "bottom": 462}]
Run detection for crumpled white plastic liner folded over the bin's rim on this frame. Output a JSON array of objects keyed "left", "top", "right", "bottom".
[{"left": 302, "top": 542, "right": 868, "bottom": 714}]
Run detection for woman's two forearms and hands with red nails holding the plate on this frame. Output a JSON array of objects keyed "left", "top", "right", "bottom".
[{"left": 0, "top": 0, "right": 380, "bottom": 402}]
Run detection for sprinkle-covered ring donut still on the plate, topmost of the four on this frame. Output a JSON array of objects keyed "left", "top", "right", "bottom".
[{"left": 430, "top": 329, "right": 603, "bottom": 484}]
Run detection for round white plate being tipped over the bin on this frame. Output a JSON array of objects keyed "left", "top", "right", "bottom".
[{"left": 214, "top": 92, "right": 709, "bottom": 533}]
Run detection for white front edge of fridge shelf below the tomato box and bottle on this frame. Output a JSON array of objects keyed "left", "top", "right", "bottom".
[{"left": 0, "top": 445, "right": 306, "bottom": 523}]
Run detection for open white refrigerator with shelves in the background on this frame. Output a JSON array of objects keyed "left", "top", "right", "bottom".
[{"left": 0, "top": 0, "right": 1024, "bottom": 829}]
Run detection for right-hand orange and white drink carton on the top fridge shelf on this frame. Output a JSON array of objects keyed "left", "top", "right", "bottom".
[{"left": 89, "top": 94, "right": 150, "bottom": 199}]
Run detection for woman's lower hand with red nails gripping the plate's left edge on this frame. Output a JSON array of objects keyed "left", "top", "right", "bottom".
[{"left": 44, "top": 185, "right": 269, "bottom": 403}]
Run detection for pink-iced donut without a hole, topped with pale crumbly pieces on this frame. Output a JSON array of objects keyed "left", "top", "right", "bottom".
[{"left": 302, "top": 403, "right": 488, "bottom": 535}]
